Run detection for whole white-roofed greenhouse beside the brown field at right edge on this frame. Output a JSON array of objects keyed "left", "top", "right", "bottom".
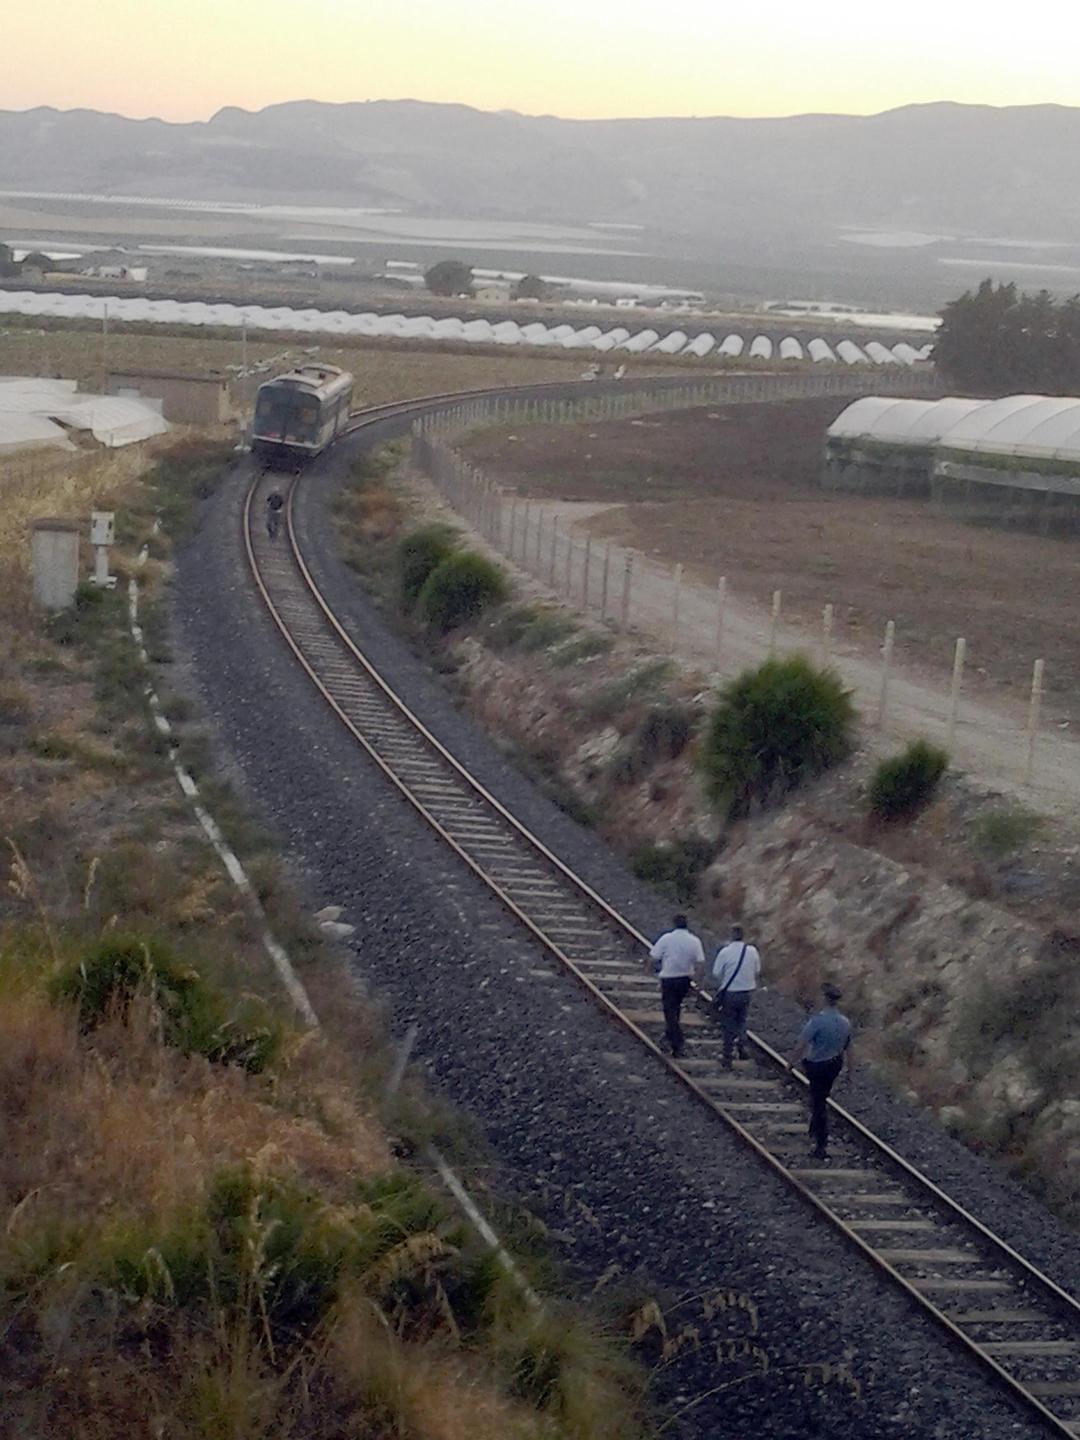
[{"left": 822, "top": 395, "right": 1080, "bottom": 530}]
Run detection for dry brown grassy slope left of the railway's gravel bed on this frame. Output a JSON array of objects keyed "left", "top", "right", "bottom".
[{"left": 0, "top": 423, "right": 641, "bottom": 1440}]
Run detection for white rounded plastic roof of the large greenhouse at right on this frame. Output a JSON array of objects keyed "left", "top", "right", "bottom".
[{"left": 828, "top": 395, "right": 1080, "bottom": 461}]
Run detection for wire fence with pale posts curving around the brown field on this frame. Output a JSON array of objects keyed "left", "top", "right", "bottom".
[{"left": 412, "top": 372, "right": 1080, "bottom": 809}]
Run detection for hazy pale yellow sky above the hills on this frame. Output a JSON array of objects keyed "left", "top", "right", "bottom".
[{"left": 8, "top": 0, "right": 1080, "bottom": 120}]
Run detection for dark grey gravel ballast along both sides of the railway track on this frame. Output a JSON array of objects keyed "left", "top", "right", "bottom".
[{"left": 174, "top": 422, "right": 1080, "bottom": 1440}]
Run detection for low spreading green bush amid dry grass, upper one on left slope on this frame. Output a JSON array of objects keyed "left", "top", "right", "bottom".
[{"left": 50, "top": 937, "right": 282, "bottom": 1074}]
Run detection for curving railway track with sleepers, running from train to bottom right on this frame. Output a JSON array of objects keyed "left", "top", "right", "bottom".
[{"left": 243, "top": 397, "right": 1080, "bottom": 1437}]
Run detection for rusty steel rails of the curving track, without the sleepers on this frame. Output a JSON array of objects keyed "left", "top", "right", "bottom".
[{"left": 243, "top": 387, "right": 1080, "bottom": 1437}]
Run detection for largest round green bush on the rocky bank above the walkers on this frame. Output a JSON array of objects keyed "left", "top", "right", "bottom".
[{"left": 701, "top": 655, "right": 855, "bottom": 816}]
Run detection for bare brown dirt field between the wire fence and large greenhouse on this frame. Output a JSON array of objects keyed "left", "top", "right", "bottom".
[{"left": 467, "top": 400, "right": 1080, "bottom": 723}]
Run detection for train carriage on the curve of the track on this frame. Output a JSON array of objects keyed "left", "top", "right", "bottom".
[{"left": 251, "top": 364, "right": 353, "bottom": 465}]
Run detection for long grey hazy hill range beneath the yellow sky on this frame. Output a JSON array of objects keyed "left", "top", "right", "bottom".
[{"left": 0, "top": 101, "right": 1080, "bottom": 248}]
